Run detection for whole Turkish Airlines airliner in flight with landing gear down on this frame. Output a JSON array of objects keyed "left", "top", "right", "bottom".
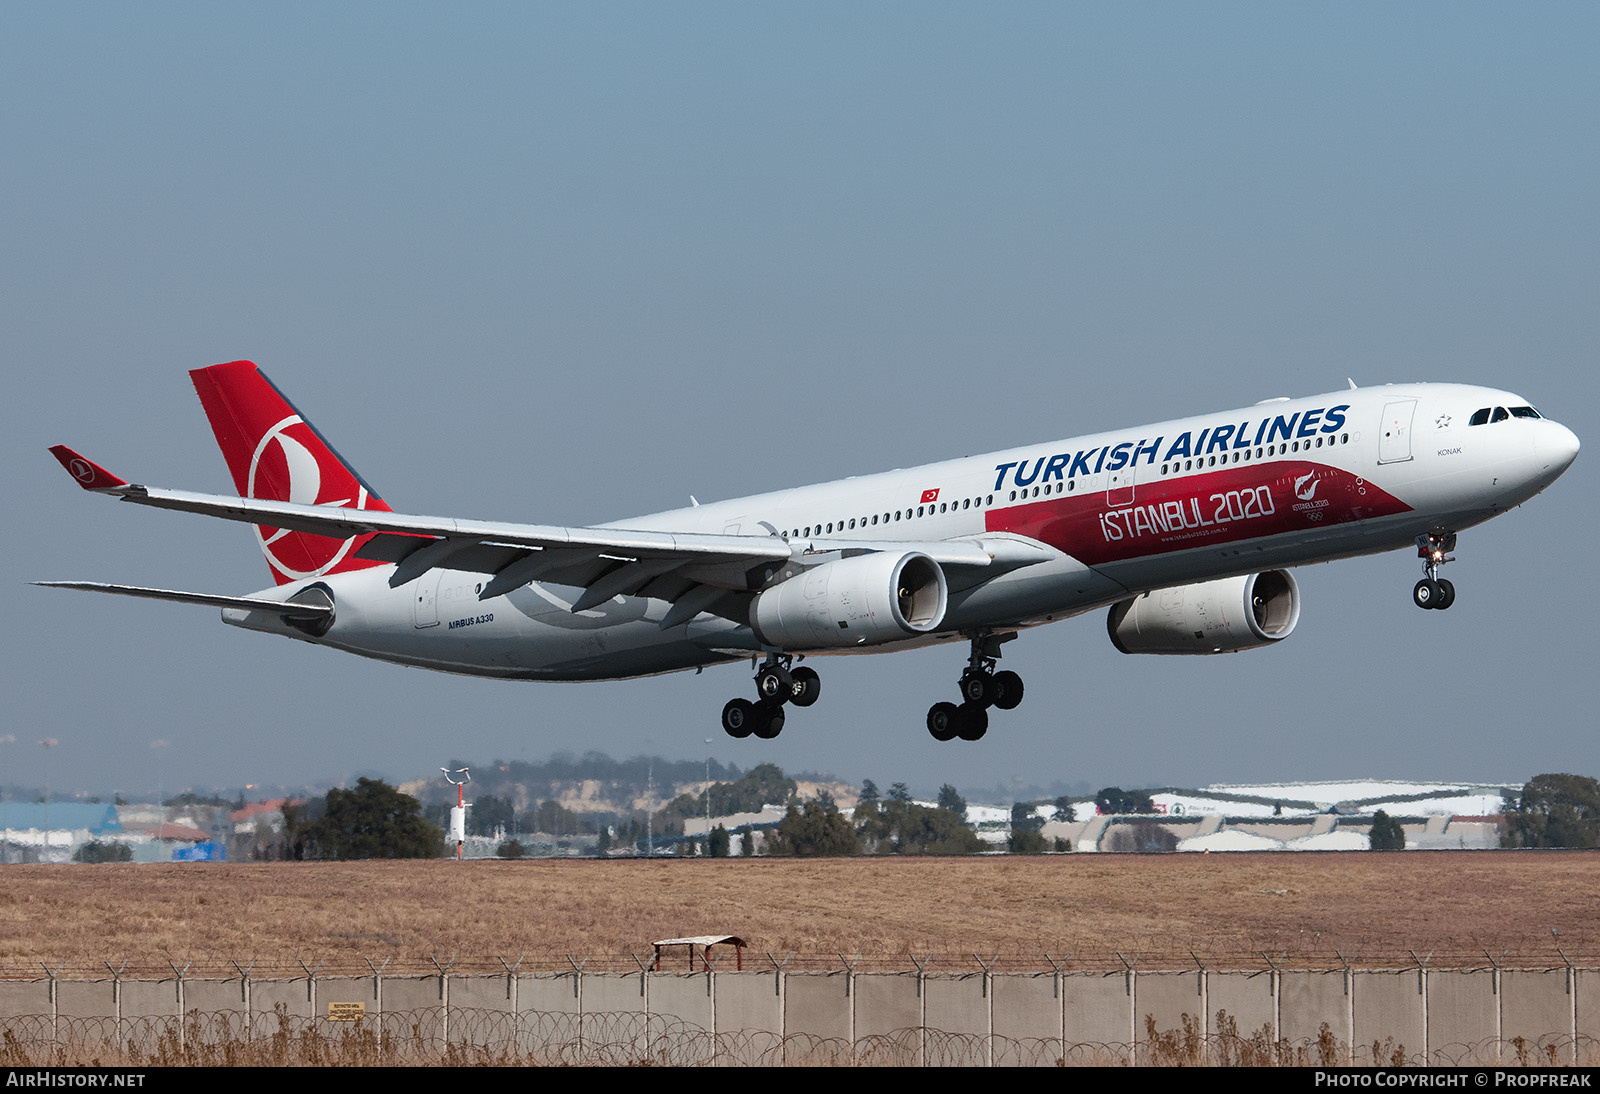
[{"left": 37, "top": 361, "right": 1579, "bottom": 741}]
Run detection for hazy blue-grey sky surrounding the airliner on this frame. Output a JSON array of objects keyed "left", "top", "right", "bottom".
[{"left": 0, "top": 3, "right": 1600, "bottom": 793}]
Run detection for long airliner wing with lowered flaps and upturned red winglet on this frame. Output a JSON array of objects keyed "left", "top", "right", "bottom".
[{"left": 51, "top": 445, "right": 1036, "bottom": 614}]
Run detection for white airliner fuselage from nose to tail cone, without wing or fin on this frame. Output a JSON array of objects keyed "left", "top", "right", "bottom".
[{"left": 222, "top": 384, "right": 1578, "bottom": 680}]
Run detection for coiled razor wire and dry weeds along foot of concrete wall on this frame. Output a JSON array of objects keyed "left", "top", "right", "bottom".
[{"left": 0, "top": 1006, "right": 1600, "bottom": 1067}]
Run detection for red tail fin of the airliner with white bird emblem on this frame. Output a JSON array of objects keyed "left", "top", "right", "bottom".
[{"left": 189, "top": 361, "right": 389, "bottom": 585}]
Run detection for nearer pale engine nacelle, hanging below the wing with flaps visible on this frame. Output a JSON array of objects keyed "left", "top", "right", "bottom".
[{"left": 750, "top": 552, "right": 949, "bottom": 649}]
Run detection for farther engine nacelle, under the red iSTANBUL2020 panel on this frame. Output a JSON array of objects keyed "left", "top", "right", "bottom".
[{"left": 1106, "top": 569, "right": 1299, "bottom": 654}]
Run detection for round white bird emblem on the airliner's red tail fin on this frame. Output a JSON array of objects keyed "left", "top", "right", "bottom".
[{"left": 245, "top": 414, "right": 368, "bottom": 581}]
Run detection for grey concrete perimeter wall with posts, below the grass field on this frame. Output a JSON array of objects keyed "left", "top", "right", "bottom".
[{"left": 0, "top": 953, "right": 1600, "bottom": 1067}]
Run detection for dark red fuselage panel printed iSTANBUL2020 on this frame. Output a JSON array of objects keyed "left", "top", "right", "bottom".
[{"left": 984, "top": 461, "right": 1411, "bottom": 566}]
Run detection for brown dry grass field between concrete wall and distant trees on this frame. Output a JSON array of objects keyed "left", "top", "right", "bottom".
[{"left": 0, "top": 852, "right": 1600, "bottom": 976}]
